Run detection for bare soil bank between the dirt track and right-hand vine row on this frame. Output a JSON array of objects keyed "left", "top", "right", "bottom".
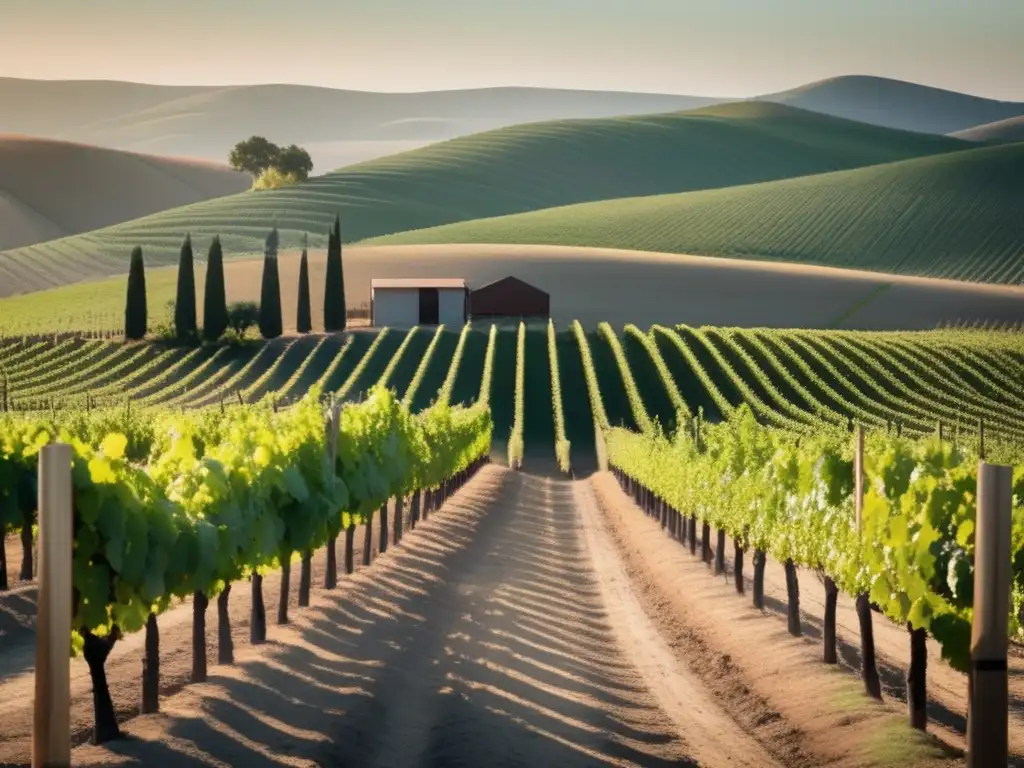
[{"left": 589, "top": 473, "right": 963, "bottom": 767}]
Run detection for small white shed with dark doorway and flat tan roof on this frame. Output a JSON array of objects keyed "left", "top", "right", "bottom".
[{"left": 370, "top": 278, "right": 469, "bottom": 328}]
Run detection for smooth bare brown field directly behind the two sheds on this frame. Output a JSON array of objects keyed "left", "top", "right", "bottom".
[{"left": 222, "top": 245, "right": 1024, "bottom": 330}]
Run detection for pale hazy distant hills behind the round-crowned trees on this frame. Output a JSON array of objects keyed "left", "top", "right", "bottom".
[{"left": 0, "top": 78, "right": 723, "bottom": 173}]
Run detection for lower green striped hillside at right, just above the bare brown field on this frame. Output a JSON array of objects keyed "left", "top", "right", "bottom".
[{"left": 375, "top": 143, "right": 1024, "bottom": 285}]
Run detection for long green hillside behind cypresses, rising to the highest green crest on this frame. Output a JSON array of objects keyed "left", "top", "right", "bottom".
[{"left": 0, "top": 102, "right": 966, "bottom": 294}]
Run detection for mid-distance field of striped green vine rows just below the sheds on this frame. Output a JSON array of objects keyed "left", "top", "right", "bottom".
[{"left": 0, "top": 324, "right": 1024, "bottom": 465}]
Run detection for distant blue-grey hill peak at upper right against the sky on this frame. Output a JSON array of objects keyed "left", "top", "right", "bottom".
[{"left": 761, "top": 75, "right": 1024, "bottom": 133}]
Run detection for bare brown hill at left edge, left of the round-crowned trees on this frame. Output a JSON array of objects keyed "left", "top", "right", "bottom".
[{"left": 0, "top": 135, "right": 251, "bottom": 249}]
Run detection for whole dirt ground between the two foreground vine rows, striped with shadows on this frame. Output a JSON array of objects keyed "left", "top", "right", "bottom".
[{"left": 0, "top": 465, "right": 991, "bottom": 768}]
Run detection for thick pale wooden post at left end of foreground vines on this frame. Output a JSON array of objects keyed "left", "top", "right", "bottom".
[{"left": 32, "top": 444, "right": 73, "bottom": 768}]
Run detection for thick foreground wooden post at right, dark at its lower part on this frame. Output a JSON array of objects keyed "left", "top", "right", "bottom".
[{"left": 967, "top": 460, "right": 1013, "bottom": 768}]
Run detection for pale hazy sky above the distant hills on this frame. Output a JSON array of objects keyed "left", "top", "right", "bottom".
[{"left": 0, "top": 0, "right": 1024, "bottom": 99}]
